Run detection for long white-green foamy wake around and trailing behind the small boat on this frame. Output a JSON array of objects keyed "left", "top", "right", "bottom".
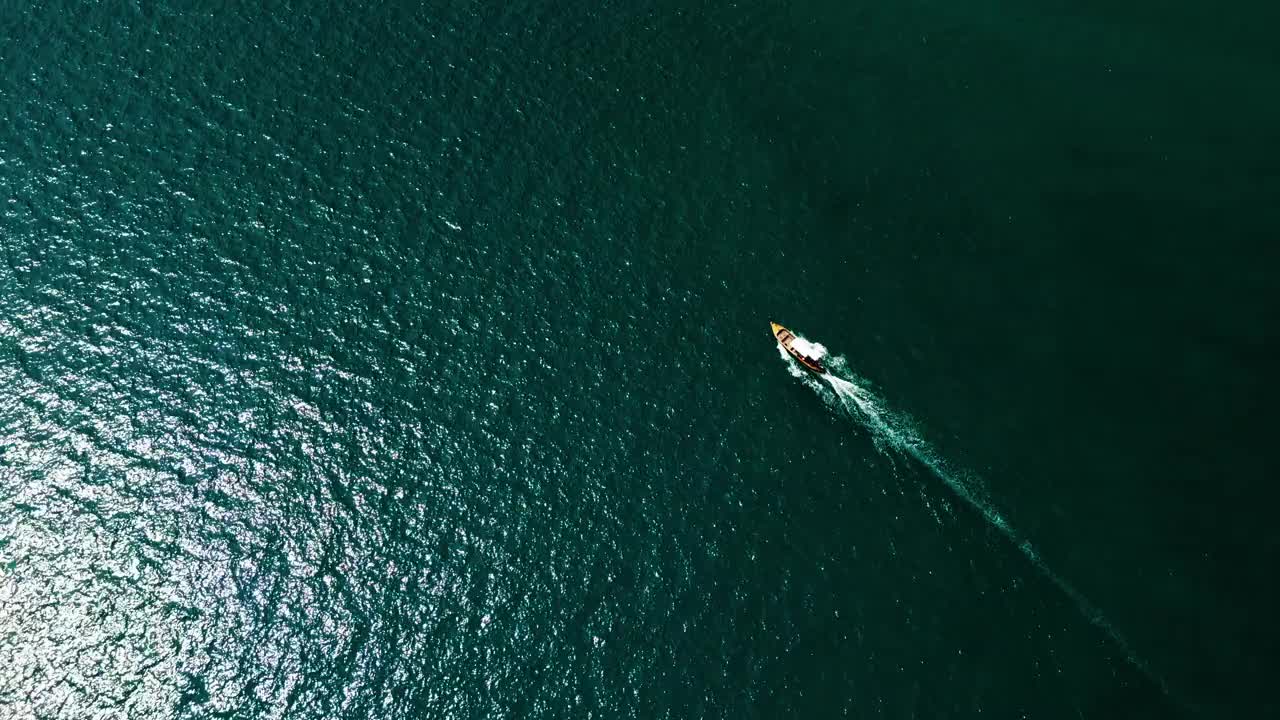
[{"left": 778, "top": 336, "right": 1174, "bottom": 698}]
